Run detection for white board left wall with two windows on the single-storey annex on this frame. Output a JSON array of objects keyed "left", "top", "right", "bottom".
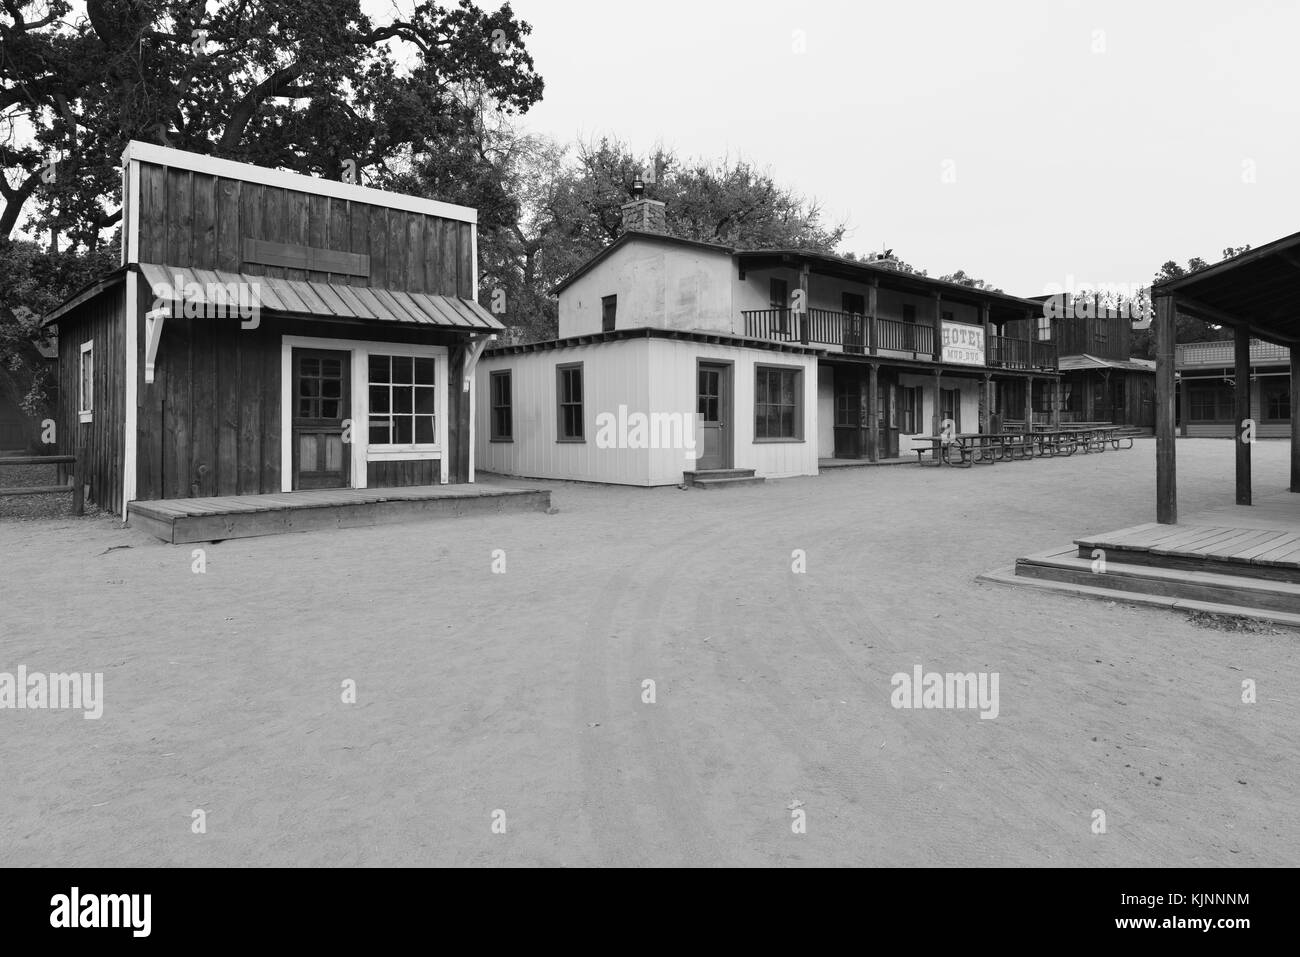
[{"left": 475, "top": 339, "right": 655, "bottom": 485}]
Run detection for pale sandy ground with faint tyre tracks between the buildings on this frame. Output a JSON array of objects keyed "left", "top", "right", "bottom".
[{"left": 0, "top": 439, "right": 1300, "bottom": 866}]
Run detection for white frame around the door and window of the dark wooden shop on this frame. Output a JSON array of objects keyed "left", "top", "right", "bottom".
[{"left": 280, "top": 335, "right": 449, "bottom": 492}]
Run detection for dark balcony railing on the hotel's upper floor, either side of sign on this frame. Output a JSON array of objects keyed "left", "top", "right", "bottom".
[{"left": 741, "top": 309, "right": 1057, "bottom": 369}]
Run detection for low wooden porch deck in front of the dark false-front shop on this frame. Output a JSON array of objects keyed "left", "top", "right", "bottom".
[{"left": 127, "top": 484, "right": 551, "bottom": 545}]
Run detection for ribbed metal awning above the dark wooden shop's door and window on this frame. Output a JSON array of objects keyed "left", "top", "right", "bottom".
[{"left": 139, "top": 263, "right": 506, "bottom": 332}]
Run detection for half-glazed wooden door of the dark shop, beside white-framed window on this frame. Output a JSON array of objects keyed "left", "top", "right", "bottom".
[{"left": 291, "top": 348, "right": 352, "bottom": 489}]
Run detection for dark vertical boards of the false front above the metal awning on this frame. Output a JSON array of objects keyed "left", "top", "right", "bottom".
[{"left": 139, "top": 163, "right": 476, "bottom": 299}]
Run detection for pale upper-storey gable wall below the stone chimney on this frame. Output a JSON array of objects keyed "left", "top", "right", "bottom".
[{"left": 559, "top": 238, "right": 735, "bottom": 339}]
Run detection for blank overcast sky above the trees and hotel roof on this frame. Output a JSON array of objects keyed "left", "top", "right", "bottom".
[{"left": 488, "top": 0, "right": 1300, "bottom": 295}]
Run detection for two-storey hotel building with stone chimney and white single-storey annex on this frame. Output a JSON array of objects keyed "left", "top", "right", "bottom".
[{"left": 476, "top": 191, "right": 1061, "bottom": 485}]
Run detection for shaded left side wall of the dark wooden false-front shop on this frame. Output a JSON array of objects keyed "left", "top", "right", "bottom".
[{"left": 49, "top": 293, "right": 126, "bottom": 511}]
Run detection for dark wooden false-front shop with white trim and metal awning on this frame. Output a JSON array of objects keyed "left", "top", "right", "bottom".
[{"left": 47, "top": 142, "right": 502, "bottom": 516}]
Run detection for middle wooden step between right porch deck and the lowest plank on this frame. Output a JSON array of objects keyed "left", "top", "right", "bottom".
[{"left": 1015, "top": 549, "right": 1300, "bottom": 615}]
